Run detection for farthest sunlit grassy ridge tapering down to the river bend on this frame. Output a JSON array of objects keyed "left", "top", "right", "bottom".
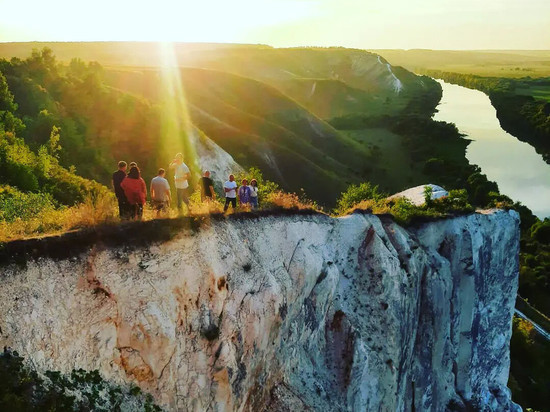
[{"left": 180, "top": 48, "right": 430, "bottom": 119}]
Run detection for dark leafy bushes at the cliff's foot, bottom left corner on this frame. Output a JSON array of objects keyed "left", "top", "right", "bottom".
[{"left": 0, "top": 351, "right": 161, "bottom": 412}]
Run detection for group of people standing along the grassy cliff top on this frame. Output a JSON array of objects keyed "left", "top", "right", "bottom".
[{"left": 112, "top": 153, "right": 258, "bottom": 220}]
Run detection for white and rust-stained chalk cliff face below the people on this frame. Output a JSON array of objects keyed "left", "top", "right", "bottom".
[{"left": 0, "top": 211, "right": 519, "bottom": 412}]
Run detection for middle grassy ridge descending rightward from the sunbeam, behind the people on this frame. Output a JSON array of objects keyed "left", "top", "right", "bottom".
[{"left": 106, "top": 68, "right": 376, "bottom": 204}]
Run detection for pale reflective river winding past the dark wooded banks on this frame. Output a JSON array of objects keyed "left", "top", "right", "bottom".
[{"left": 434, "top": 80, "right": 550, "bottom": 218}]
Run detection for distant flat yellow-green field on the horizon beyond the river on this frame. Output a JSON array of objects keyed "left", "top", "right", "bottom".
[{"left": 370, "top": 49, "right": 550, "bottom": 78}]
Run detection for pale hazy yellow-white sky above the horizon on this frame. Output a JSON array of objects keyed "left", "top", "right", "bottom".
[{"left": 0, "top": 0, "right": 550, "bottom": 49}]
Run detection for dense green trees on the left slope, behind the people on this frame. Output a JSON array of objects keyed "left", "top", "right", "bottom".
[{"left": 0, "top": 49, "right": 166, "bottom": 184}]
